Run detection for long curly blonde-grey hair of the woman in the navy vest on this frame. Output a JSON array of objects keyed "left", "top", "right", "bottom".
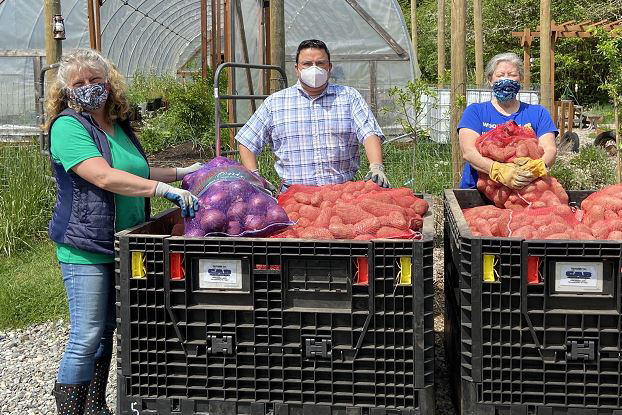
[{"left": 45, "top": 49, "right": 130, "bottom": 129}]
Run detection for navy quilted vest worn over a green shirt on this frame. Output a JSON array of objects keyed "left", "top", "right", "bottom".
[{"left": 48, "top": 108, "right": 151, "bottom": 255}]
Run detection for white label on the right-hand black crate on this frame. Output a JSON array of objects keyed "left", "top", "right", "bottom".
[{"left": 555, "top": 262, "right": 603, "bottom": 293}]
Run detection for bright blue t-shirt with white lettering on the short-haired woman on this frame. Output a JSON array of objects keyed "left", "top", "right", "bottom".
[{"left": 458, "top": 101, "right": 559, "bottom": 189}]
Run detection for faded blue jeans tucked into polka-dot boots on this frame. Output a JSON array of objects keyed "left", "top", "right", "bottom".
[{"left": 56, "top": 262, "right": 116, "bottom": 384}]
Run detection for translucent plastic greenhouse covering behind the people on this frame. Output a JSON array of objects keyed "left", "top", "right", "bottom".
[{"left": 0, "top": 0, "right": 419, "bottom": 135}]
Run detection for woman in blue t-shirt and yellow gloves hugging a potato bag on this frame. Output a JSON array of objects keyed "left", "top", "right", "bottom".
[{"left": 458, "top": 53, "right": 558, "bottom": 189}]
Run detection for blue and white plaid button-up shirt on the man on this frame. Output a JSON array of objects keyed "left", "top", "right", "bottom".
[{"left": 235, "top": 82, "right": 384, "bottom": 186}]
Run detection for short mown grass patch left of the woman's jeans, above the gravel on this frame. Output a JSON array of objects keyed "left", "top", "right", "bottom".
[{"left": 0, "top": 241, "right": 68, "bottom": 330}]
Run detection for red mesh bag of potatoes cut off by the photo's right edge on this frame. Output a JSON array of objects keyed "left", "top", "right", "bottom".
[{"left": 581, "top": 184, "right": 622, "bottom": 240}]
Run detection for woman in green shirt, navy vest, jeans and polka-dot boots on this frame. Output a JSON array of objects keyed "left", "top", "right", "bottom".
[{"left": 46, "top": 49, "right": 200, "bottom": 415}]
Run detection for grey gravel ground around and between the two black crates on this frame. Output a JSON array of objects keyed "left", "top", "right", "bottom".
[{"left": 0, "top": 248, "right": 455, "bottom": 415}]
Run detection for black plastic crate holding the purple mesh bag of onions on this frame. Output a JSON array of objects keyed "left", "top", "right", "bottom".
[{"left": 117, "top": 197, "right": 434, "bottom": 415}]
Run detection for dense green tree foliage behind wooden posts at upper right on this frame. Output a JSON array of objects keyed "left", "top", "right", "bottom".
[{"left": 398, "top": 0, "right": 622, "bottom": 105}]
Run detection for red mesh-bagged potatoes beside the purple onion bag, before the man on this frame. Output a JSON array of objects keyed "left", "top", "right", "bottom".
[{"left": 274, "top": 181, "right": 429, "bottom": 240}]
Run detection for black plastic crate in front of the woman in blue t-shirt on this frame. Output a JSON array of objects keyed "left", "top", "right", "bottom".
[{"left": 444, "top": 190, "right": 622, "bottom": 415}]
